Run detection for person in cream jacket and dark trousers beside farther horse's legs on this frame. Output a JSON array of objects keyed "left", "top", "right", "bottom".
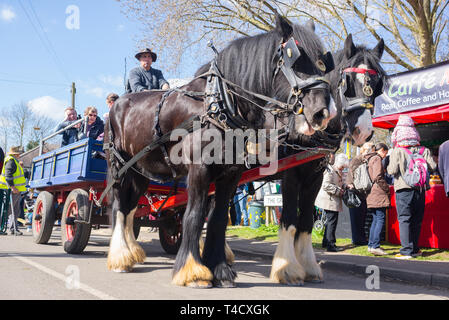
[{"left": 315, "top": 153, "right": 349, "bottom": 252}]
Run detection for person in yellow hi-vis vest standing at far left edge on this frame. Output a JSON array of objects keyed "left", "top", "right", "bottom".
[{"left": 0, "top": 147, "right": 27, "bottom": 235}]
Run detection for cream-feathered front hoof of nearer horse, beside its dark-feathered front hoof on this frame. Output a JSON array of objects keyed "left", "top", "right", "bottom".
[{"left": 172, "top": 254, "right": 213, "bottom": 288}]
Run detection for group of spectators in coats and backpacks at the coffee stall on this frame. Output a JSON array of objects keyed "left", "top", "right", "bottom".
[{"left": 315, "top": 115, "right": 442, "bottom": 260}]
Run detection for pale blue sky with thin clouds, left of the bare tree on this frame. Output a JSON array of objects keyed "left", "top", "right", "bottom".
[{"left": 0, "top": 0, "right": 199, "bottom": 120}]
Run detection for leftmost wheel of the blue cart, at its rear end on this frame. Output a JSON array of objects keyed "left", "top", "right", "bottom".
[{"left": 32, "top": 191, "right": 55, "bottom": 244}]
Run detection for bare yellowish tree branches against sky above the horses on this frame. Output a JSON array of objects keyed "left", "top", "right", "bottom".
[{"left": 119, "top": 0, "right": 449, "bottom": 71}]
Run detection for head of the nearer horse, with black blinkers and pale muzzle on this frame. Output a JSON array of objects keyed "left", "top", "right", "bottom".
[{"left": 273, "top": 15, "right": 337, "bottom": 137}]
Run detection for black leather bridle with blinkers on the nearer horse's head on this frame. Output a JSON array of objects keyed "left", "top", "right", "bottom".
[{"left": 273, "top": 37, "right": 334, "bottom": 115}]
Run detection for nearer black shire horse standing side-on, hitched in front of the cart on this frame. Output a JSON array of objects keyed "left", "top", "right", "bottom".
[{"left": 105, "top": 15, "right": 332, "bottom": 288}]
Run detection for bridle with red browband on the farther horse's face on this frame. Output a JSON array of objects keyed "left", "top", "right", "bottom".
[{"left": 338, "top": 67, "right": 383, "bottom": 114}]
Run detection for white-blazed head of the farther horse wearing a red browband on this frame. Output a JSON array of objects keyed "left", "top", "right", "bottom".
[{"left": 331, "top": 35, "right": 385, "bottom": 146}]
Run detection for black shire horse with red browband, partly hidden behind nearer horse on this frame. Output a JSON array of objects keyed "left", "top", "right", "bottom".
[{"left": 270, "top": 35, "right": 385, "bottom": 285}]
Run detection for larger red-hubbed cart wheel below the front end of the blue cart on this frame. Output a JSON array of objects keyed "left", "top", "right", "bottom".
[{"left": 61, "top": 189, "right": 91, "bottom": 254}]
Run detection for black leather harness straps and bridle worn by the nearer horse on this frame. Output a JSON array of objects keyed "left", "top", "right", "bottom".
[{"left": 99, "top": 38, "right": 333, "bottom": 203}]
